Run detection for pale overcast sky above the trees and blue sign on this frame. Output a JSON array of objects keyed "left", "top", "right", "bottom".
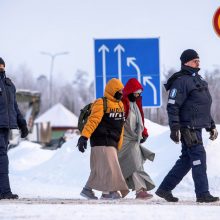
[{"left": 0, "top": 0, "right": 220, "bottom": 80}]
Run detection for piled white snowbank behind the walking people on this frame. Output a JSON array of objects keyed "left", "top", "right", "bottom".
[{"left": 9, "top": 120, "right": 220, "bottom": 198}]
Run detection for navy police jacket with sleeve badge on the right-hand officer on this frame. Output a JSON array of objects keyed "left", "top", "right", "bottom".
[{"left": 165, "top": 65, "right": 215, "bottom": 129}]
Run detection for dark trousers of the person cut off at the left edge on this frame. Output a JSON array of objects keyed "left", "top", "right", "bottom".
[{"left": 0, "top": 128, "right": 11, "bottom": 194}]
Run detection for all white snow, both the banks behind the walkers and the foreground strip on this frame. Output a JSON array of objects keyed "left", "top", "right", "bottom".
[{"left": 0, "top": 120, "right": 220, "bottom": 220}]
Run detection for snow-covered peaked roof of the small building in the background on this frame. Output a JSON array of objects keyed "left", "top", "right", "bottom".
[{"left": 34, "top": 103, "right": 78, "bottom": 127}]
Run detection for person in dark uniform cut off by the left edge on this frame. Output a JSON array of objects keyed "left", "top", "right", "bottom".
[{"left": 0, "top": 57, "right": 28, "bottom": 199}]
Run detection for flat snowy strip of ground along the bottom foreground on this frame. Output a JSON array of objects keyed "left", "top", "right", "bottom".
[{"left": 0, "top": 204, "right": 220, "bottom": 220}]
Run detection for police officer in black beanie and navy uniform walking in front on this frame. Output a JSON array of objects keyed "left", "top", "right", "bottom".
[{"left": 156, "top": 49, "right": 219, "bottom": 202}]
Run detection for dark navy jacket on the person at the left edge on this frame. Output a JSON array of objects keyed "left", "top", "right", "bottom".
[{"left": 0, "top": 72, "right": 26, "bottom": 129}]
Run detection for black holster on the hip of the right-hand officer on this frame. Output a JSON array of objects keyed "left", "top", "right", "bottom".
[{"left": 180, "top": 128, "right": 202, "bottom": 147}]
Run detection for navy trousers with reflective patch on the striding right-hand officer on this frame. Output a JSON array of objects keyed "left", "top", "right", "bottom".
[{"left": 159, "top": 130, "right": 209, "bottom": 197}]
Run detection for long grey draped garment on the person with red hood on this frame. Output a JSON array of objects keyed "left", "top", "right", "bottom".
[{"left": 118, "top": 102, "right": 155, "bottom": 191}]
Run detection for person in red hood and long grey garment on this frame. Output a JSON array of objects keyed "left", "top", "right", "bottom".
[{"left": 118, "top": 78, "right": 155, "bottom": 199}]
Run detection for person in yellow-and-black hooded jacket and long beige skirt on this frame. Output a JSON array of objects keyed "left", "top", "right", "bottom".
[{"left": 77, "top": 78, "right": 129, "bottom": 199}]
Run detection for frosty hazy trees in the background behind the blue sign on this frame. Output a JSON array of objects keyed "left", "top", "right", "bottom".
[{"left": 7, "top": 65, "right": 220, "bottom": 125}]
